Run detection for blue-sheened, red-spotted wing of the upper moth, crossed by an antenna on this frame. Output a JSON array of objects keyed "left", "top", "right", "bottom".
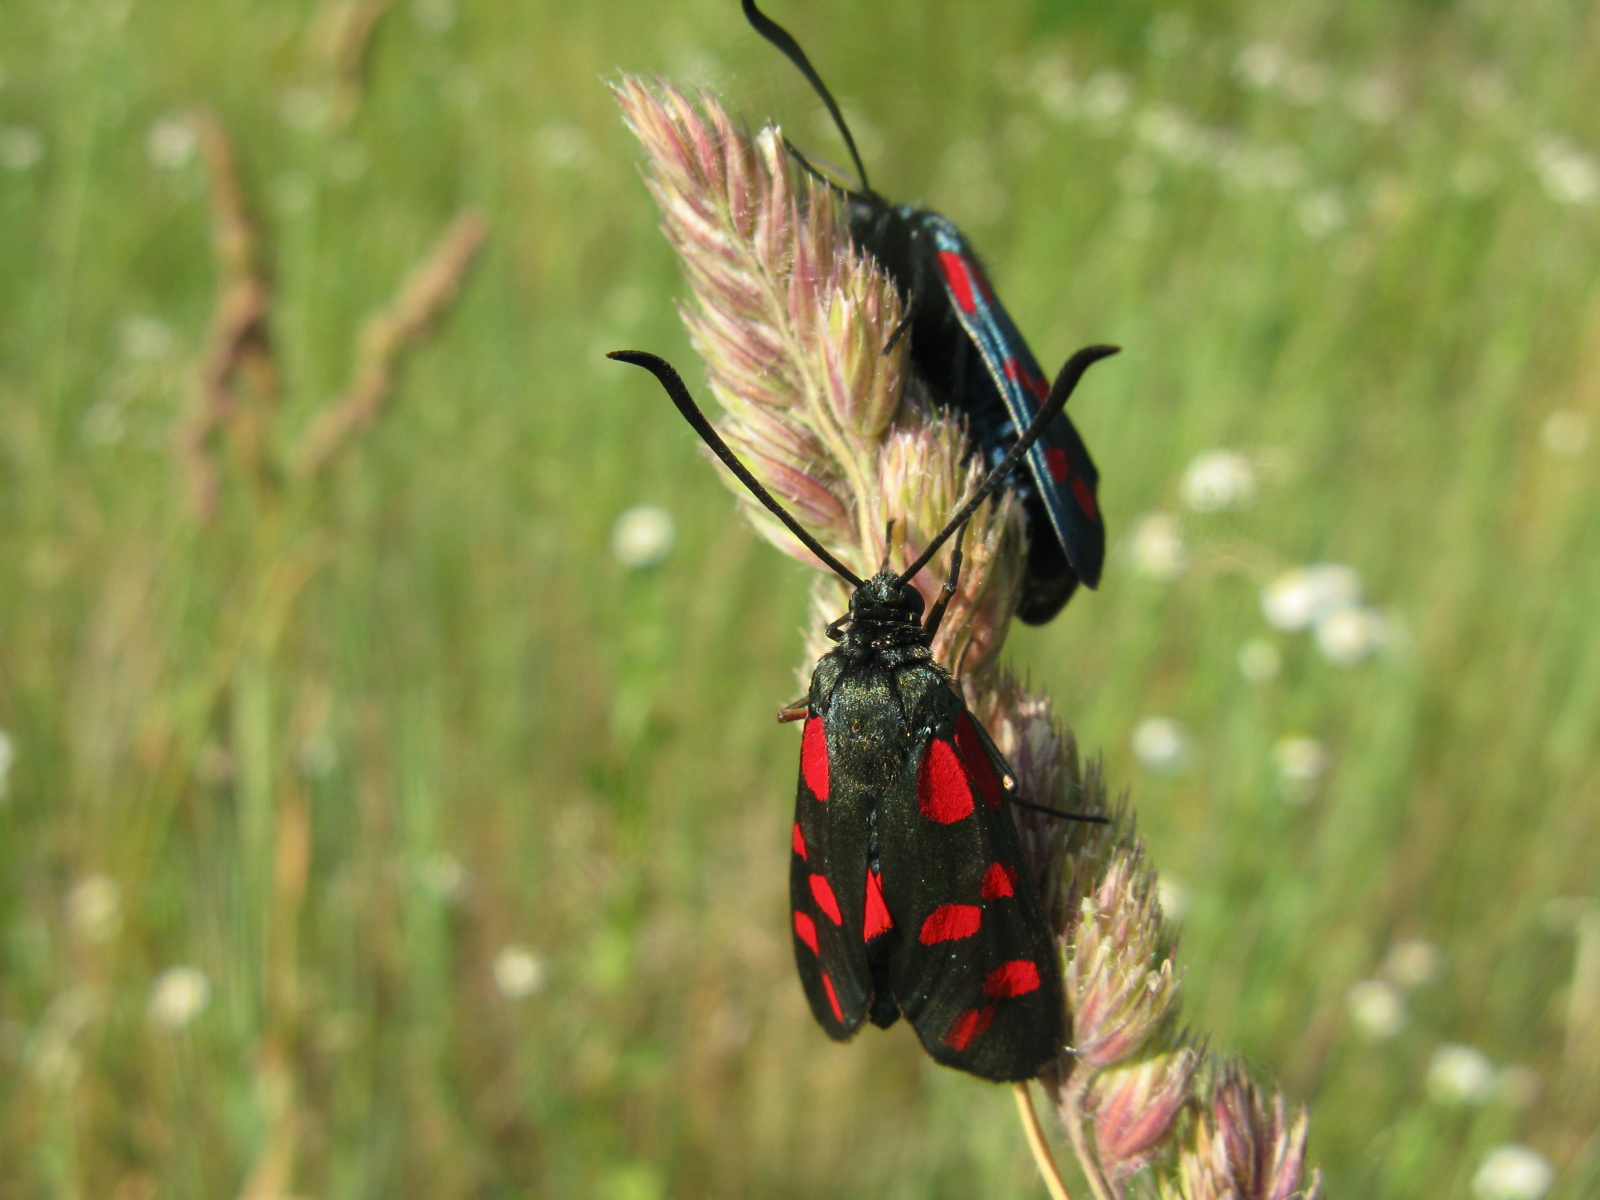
[{"left": 923, "top": 213, "right": 1106, "bottom": 587}]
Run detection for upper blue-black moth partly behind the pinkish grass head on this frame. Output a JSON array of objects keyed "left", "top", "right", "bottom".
[{"left": 742, "top": 0, "right": 1106, "bottom": 626}]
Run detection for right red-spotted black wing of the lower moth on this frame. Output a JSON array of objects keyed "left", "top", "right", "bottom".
[{"left": 878, "top": 678, "right": 1066, "bottom": 1080}]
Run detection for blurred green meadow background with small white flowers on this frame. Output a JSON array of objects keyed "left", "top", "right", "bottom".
[{"left": 0, "top": 0, "right": 1600, "bottom": 1200}]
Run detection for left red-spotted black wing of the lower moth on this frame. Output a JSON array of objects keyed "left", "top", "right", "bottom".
[{"left": 789, "top": 709, "right": 872, "bottom": 1042}]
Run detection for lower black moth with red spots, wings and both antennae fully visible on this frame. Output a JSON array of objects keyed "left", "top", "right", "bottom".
[{"left": 610, "top": 346, "right": 1117, "bottom": 1080}]
